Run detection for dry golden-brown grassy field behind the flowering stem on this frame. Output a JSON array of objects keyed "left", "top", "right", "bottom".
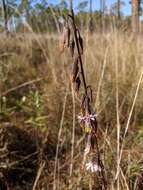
[{"left": 0, "top": 31, "right": 143, "bottom": 190}]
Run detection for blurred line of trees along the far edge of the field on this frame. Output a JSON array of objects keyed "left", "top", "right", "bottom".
[{"left": 0, "top": 0, "right": 143, "bottom": 33}]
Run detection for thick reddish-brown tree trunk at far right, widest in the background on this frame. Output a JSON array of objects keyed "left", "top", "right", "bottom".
[{"left": 132, "top": 0, "right": 139, "bottom": 33}]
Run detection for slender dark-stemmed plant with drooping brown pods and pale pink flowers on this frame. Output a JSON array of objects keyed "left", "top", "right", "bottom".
[{"left": 60, "top": 10, "right": 107, "bottom": 189}]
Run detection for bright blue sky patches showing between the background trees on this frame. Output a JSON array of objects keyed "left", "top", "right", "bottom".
[{"left": 48, "top": 0, "right": 131, "bottom": 15}]
